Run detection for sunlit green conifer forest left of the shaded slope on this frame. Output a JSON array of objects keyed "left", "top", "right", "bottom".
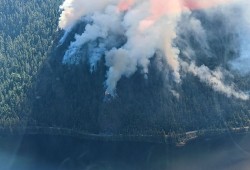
[{"left": 0, "top": 0, "right": 60, "bottom": 126}]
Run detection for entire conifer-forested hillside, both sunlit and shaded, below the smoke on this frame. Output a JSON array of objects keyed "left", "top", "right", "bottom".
[{"left": 0, "top": 0, "right": 250, "bottom": 134}]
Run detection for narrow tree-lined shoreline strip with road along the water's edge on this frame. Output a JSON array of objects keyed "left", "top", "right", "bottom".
[{"left": 0, "top": 126, "right": 250, "bottom": 147}]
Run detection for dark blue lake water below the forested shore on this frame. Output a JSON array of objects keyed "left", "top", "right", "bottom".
[{"left": 0, "top": 135, "right": 250, "bottom": 170}]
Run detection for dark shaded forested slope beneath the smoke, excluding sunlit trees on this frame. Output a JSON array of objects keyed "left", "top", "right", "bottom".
[{"left": 32, "top": 10, "right": 249, "bottom": 134}]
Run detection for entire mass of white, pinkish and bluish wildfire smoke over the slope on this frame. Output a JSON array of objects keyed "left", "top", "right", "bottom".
[{"left": 59, "top": 0, "right": 250, "bottom": 100}]
